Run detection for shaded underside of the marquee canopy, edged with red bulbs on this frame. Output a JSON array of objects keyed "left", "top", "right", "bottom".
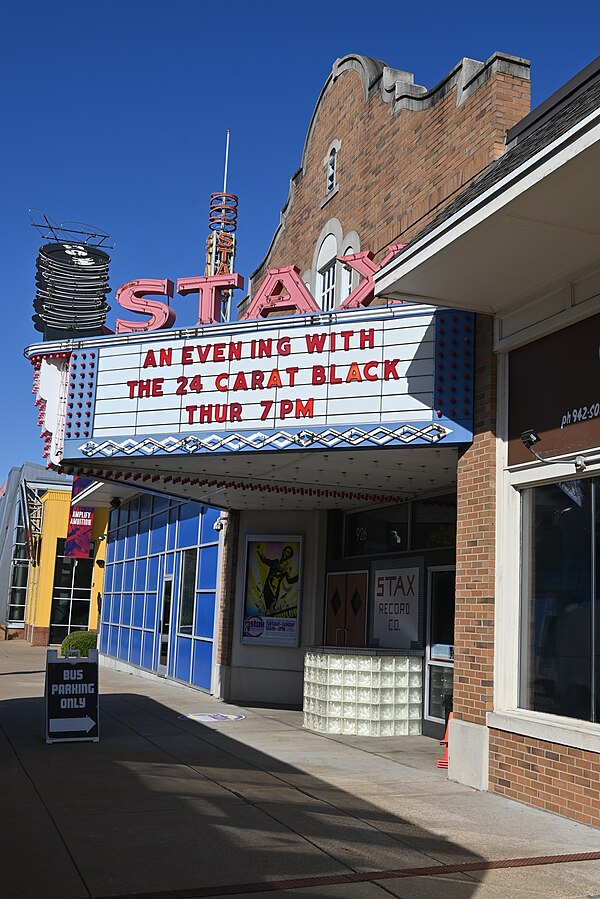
[{"left": 65, "top": 446, "right": 457, "bottom": 510}]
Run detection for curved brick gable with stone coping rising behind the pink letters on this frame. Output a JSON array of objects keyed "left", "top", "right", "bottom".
[{"left": 247, "top": 54, "right": 530, "bottom": 307}]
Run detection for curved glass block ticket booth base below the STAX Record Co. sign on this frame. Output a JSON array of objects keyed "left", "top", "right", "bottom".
[{"left": 303, "top": 651, "right": 423, "bottom": 737}]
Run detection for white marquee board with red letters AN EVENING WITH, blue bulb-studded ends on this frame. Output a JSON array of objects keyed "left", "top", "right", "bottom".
[{"left": 44, "top": 306, "right": 472, "bottom": 459}]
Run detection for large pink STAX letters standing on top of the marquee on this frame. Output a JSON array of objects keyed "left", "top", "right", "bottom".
[{"left": 116, "top": 244, "right": 404, "bottom": 334}]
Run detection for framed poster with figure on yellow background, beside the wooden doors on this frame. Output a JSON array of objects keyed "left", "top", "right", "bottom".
[{"left": 242, "top": 534, "right": 302, "bottom": 646}]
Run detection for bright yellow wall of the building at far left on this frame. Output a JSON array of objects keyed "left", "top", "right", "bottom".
[{"left": 26, "top": 488, "right": 108, "bottom": 630}]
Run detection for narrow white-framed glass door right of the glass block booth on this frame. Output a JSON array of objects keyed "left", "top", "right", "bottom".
[{"left": 424, "top": 566, "right": 456, "bottom": 725}]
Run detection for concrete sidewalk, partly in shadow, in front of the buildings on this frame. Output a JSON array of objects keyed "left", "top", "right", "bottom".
[{"left": 0, "top": 641, "right": 600, "bottom": 899}]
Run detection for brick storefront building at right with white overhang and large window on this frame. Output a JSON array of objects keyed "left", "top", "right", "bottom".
[{"left": 375, "top": 59, "right": 600, "bottom": 825}]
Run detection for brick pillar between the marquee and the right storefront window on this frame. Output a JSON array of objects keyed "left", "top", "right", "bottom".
[{"left": 454, "top": 315, "right": 497, "bottom": 725}]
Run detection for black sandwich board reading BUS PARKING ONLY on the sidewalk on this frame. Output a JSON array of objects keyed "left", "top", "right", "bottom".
[{"left": 45, "top": 649, "right": 100, "bottom": 743}]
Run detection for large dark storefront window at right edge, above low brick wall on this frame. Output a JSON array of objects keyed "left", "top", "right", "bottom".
[{"left": 519, "top": 478, "right": 600, "bottom": 721}]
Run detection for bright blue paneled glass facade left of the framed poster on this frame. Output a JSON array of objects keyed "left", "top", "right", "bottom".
[{"left": 99, "top": 494, "right": 219, "bottom": 690}]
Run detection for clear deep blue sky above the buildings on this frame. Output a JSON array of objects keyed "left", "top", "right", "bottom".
[{"left": 0, "top": 0, "right": 600, "bottom": 482}]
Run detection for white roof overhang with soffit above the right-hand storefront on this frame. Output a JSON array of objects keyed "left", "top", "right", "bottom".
[{"left": 375, "top": 110, "right": 600, "bottom": 314}]
